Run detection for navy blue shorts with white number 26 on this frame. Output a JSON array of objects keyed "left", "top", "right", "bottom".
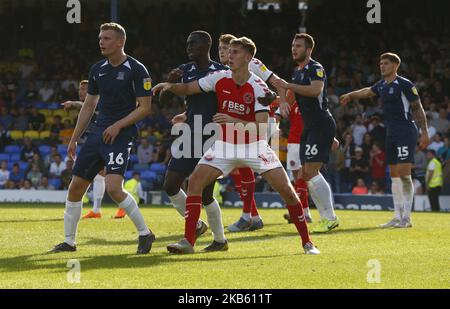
[{"left": 300, "top": 117, "right": 336, "bottom": 165}]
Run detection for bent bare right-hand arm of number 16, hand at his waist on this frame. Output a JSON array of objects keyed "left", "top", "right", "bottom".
[{"left": 103, "top": 97, "right": 152, "bottom": 144}]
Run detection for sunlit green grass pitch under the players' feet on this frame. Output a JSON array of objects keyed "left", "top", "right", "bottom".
[{"left": 0, "top": 204, "right": 450, "bottom": 289}]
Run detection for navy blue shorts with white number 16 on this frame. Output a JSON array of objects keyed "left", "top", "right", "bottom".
[{"left": 73, "top": 130, "right": 134, "bottom": 181}]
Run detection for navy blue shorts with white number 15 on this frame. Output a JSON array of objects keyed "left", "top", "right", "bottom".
[{"left": 386, "top": 125, "right": 418, "bottom": 165}]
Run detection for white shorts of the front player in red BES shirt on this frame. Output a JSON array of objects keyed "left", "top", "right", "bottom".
[{"left": 198, "top": 140, "right": 283, "bottom": 176}]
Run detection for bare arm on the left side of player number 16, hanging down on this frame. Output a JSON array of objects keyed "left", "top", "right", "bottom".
[{"left": 67, "top": 94, "right": 99, "bottom": 160}]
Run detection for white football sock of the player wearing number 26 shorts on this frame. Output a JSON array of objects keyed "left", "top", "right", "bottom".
[{"left": 307, "top": 173, "right": 336, "bottom": 220}]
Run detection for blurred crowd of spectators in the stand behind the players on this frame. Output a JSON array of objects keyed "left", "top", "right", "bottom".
[{"left": 0, "top": 2, "right": 450, "bottom": 194}]
